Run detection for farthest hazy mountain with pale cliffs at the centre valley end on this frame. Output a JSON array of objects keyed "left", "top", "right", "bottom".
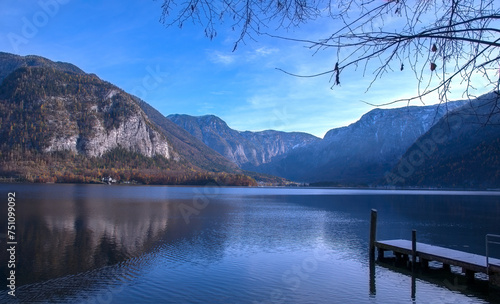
[{"left": 168, "top": 114, "right": 319, "bottom": 171}]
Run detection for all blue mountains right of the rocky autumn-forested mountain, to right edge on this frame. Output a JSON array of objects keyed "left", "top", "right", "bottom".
[{"left": 168, "top": 98, "right": 500, "bottom": 188}]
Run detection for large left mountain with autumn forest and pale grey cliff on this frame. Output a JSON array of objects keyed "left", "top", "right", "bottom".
[{"left": 0, "top": 53, "right": 255, "bottom": 185}]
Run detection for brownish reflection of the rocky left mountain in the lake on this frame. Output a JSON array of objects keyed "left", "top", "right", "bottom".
[{"left": 0, "top": 185, "right": 236, "bottom": 286}]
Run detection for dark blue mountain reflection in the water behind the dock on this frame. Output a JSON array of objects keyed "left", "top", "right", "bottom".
[{"left": 289, "top": 191, "right": 500, "bottom": 257}]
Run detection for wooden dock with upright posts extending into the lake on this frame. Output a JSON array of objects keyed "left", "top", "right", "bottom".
[{"left": 370, "top": 210, "right": 500, "bottom": 287}]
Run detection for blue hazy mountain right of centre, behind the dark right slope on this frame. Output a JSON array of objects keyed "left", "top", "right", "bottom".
[{"left": 256, "top": 102, "right": 463, "bottom": 185}]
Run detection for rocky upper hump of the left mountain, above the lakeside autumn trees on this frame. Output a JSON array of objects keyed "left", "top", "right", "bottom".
[{"left": 0, "top": 66, "right": 174, "bottom": 159}]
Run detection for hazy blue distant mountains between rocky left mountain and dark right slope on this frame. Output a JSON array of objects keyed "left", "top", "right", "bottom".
[{"left": 168, "top": 102, "right": 465, "bottom": 185}]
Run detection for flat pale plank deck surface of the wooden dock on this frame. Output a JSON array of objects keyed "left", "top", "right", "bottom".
[{"left": 375, "top": 240, "right": 500, "bottom": 273}]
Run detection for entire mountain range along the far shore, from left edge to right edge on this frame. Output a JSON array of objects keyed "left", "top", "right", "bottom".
[{"left": 0, "top": 52, "right": 500, "bottom": 188}]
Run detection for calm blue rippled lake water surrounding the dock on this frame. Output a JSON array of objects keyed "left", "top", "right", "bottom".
[{"left": 0, "top": 184, "right": 500, "bottom": 304}]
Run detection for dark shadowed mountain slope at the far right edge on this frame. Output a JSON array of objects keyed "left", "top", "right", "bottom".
[{"left": 385, "top": 92, "right": 500, "bottom": 188}]
